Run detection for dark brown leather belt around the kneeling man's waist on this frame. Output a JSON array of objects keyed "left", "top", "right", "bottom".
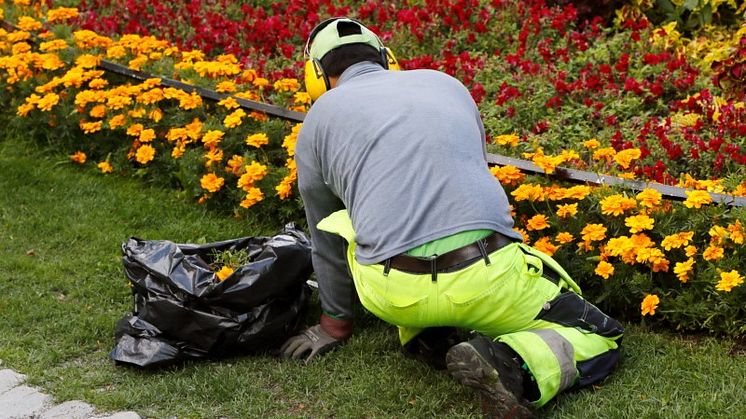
[{"left": 382, "top": 232, "right": 515, "bottom": 280}]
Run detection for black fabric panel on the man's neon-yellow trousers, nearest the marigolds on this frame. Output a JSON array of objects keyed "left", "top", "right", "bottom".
[{"left": 536, "top": 291, "right": 624, "bottom": 338}]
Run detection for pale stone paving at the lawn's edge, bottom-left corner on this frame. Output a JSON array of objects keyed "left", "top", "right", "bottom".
[{"left": 0, "top": 369, "right": 141, "bottom": 419}]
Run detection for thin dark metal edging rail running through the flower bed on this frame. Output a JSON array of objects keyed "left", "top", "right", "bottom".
[{"left": 0, "top": 19, "right": 746, "bottom": 207}]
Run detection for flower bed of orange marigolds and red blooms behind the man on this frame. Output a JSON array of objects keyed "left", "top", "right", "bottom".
[{"left": 0, "top": 0, "right": 746, "bottom": 335}]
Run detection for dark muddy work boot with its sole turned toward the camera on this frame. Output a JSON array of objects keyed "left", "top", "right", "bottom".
[{"left": 446, "top": 336, "right": 534, "bottom": 419}]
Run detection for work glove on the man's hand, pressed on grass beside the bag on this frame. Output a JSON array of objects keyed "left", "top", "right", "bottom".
[{"left": 280, "top": 314, "right": 352, "bottom": 364}]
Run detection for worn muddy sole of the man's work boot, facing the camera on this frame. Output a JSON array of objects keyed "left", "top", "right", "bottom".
[{"left": 446, "top": 343, "right": 534, "bottom": 419}]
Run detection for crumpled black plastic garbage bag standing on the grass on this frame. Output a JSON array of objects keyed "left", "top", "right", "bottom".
[{"left": 109, "top": 225, "right": 312, "bottom": 367}]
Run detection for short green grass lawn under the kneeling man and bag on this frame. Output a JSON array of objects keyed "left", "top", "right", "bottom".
[{"left": 0, "top": 136, "right": 746, "bottom": 418}]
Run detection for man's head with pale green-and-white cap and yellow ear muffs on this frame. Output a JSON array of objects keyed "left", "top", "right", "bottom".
[{"left": 305, "top": 18, "right": 399, "bottom": 100}]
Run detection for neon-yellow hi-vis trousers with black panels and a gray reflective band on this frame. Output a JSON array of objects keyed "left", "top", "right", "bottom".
[{"left": 318, "top": 210, "right": 623, "bottom": 407}]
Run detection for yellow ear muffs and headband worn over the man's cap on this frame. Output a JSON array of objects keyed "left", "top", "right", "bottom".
[{"left": 303, "top": 17, "right": 400, "bottom": 101}]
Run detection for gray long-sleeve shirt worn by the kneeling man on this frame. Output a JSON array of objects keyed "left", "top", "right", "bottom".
[{"left": 295, "top": 62, "right": 521, "bottom": 317}]
